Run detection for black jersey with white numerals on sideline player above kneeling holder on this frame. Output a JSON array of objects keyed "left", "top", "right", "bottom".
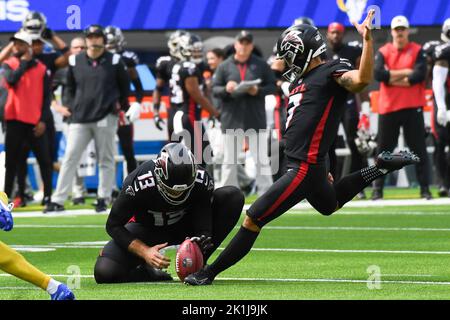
[{"left": 170, "top": 61, "right": 204, "bottom": 120}]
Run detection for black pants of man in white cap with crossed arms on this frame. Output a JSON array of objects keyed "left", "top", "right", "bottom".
[{"left": 374, "top": 107, "right": 430, "bottom": 190}]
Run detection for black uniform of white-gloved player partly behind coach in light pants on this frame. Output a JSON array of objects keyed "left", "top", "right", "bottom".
[{"left": 117, "top": 50, "right": 144, "bottom": 173}]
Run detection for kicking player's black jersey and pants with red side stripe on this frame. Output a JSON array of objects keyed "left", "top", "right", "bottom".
[{"left": 247, "top": 59, "right": 362, "bottom": 227}]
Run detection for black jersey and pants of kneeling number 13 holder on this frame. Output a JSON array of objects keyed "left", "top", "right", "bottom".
[{"left": 95, "top": 160, "right": 244, "bottom": 283}]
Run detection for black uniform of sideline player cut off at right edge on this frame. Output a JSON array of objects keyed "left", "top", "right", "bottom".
[{"left": 430, "top": 43, "right": 450, "bottom": 190}]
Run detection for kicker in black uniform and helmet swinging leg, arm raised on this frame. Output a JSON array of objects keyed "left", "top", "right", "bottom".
[{"left": 184, "top": 10, "right": 418, "bottom": 285}]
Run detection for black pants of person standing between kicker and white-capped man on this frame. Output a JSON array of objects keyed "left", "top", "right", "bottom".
[{"left": 328, "top": 100, "right": 367, "bottom": 180}]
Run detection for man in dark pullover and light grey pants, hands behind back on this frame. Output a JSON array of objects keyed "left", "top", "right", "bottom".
[{"left": 44, "top": 25, "right": 130, "bottom": 212}]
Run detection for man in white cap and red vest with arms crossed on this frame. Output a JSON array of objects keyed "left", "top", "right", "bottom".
[{"left": 372, "top": 16, "right": 432, "bottom": 200}]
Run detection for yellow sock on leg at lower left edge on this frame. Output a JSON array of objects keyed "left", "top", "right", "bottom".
[{"left": 0, "top": 241, "right": 51, "bottom": 290}]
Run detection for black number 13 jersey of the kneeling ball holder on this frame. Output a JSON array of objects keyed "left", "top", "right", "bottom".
[{"left": 106, "top": 160, "right": 214, "bottom": 248}]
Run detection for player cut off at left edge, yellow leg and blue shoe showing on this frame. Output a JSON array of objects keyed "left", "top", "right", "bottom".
[{"left": 0, "top": 192, "right": 75, "bottom": 300}]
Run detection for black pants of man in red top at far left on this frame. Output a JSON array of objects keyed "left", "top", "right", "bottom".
[{"left": 5, "top": 121, "right": 53, "bottom": 199}]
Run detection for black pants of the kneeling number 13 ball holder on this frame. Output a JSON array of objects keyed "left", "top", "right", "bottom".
[{"left": 94, "top": 186, "right": 244, "bottom": 283}]
